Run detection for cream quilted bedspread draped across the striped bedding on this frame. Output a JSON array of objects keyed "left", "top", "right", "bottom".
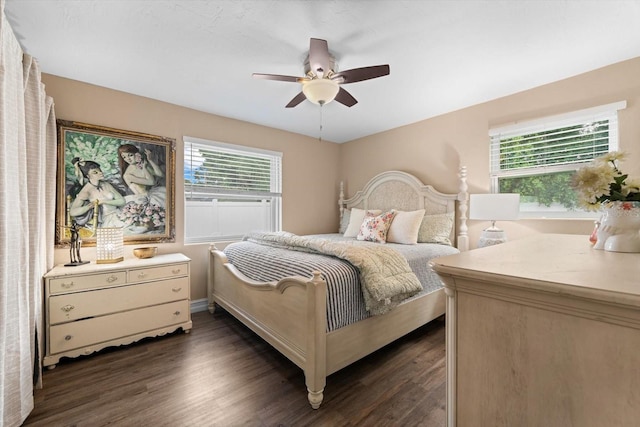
[{"left": 243, "top": 232, "right": 422, "bottom": 315}]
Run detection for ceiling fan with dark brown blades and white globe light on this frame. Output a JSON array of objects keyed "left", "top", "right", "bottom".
[{"left": 253, "top": 39, "right": 389, "bottom": 108}]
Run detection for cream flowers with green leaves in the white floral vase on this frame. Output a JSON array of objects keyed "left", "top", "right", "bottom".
[{"left": 571, "top": 151, "right": 640, "bottom": 211}]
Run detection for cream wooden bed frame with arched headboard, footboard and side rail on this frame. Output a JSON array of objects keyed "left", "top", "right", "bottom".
[{"left": 208, "top": 167, "right": 468, "bottom": 409}]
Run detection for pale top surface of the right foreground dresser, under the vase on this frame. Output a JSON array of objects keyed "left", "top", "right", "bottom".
[{"left": 432, "top": 234, "right": 640, "bottom": 307}]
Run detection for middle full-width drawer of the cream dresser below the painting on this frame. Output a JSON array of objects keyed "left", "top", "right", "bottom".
[{"left": 49, "top": 277, "right": 189, "bottom": 325}]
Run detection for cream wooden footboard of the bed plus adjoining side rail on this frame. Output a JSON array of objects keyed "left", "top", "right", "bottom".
[{"left": 208, "top": 242, "right": 445, "bottom": 409}]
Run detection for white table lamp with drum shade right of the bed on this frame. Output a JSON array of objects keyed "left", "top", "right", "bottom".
[{"left": 469, "top": 193, "right": 520, "bottom": 248}]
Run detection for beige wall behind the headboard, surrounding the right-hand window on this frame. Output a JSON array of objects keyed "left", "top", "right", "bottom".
[{"left": 340, "top": 58, "right": 640, "bottom": 251}]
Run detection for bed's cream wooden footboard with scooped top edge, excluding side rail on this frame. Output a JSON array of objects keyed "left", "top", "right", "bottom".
[{"left": 208, "top": 246, "right": 327, "bottom": 409}]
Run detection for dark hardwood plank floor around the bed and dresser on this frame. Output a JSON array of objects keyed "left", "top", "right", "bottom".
[{"left": 24, "top": 309, "right": 445, "bottom": 427}]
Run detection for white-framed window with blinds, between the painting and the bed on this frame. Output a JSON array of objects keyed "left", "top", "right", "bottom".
[{"left": 184, "top": 137, "right": 282, "bottom": 243}]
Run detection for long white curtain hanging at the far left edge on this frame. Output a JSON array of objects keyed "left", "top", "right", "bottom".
[{"left": 0, "top": 0, "right": 56, "bottom": 426}]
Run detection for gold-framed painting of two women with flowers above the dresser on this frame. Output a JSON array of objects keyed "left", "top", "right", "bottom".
[{"left": 55, "top": 120, "right": 176, "bottom": 247}]
